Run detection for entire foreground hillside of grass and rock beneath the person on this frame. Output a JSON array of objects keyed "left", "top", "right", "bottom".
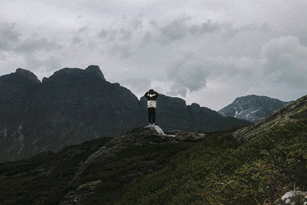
[{"left": 0, "top": 93, "right": 307, "bottom": 205}]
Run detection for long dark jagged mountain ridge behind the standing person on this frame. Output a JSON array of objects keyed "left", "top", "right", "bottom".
[{"left": 0, "top": 65, "right": 249, "bottom": 162}]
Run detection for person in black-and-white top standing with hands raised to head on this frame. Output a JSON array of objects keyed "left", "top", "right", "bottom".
[{"left": 144, "top": 89, "right": 159, "bottom": 125}]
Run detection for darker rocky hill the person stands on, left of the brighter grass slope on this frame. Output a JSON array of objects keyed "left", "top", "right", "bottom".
[{"left": 0, "top": 127, "right": 205, "bottom": 205}]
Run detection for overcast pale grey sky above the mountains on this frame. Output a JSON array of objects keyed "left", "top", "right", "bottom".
[{"left": 0, "top": 0, "right": 307, "bottom": 110}]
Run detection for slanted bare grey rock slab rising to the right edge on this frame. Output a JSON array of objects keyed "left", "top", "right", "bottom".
[{"left": 233, "top": 96, "right": 307, "bottom": 144}]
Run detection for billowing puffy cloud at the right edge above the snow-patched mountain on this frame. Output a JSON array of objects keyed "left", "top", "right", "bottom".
[{"left": 261, "top": 36, "right": 307, "bottom": 87}]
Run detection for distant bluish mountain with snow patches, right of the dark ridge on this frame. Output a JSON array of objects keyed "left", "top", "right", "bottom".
[{"left": 218, "top": 95, "right": 290, "bottom": 122}]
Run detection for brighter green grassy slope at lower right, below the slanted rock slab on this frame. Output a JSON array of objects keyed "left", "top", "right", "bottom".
[{"left": 117, "top": 121, "right": 307, "bottom": 204}]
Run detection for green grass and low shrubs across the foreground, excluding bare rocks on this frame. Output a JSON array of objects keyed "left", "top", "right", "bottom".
[{"left": 0, "top": 120, "right": 307, "bottom": 205}]
